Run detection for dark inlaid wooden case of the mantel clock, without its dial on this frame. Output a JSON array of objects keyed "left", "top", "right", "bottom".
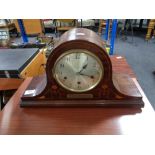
[{"left": 21, "top": 28, "right": 144, "bottom": 107}]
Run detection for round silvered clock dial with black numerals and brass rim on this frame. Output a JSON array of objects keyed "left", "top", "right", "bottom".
[{"left": 53, "top": 49, "right": 103, "bottom": 92}]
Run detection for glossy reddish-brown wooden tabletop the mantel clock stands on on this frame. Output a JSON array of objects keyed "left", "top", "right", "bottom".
[{"left": 0, "top": 56, "right": 155, "bottom": 135}]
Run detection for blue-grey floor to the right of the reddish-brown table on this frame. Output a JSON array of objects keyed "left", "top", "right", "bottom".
[{"left": 114, "top": 34, "right": 155, "bottom": 109}]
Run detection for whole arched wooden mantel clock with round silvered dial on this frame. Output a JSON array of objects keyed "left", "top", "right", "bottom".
[{"left": 20, "top": 28, "right": 144, "bottom": 107}]
